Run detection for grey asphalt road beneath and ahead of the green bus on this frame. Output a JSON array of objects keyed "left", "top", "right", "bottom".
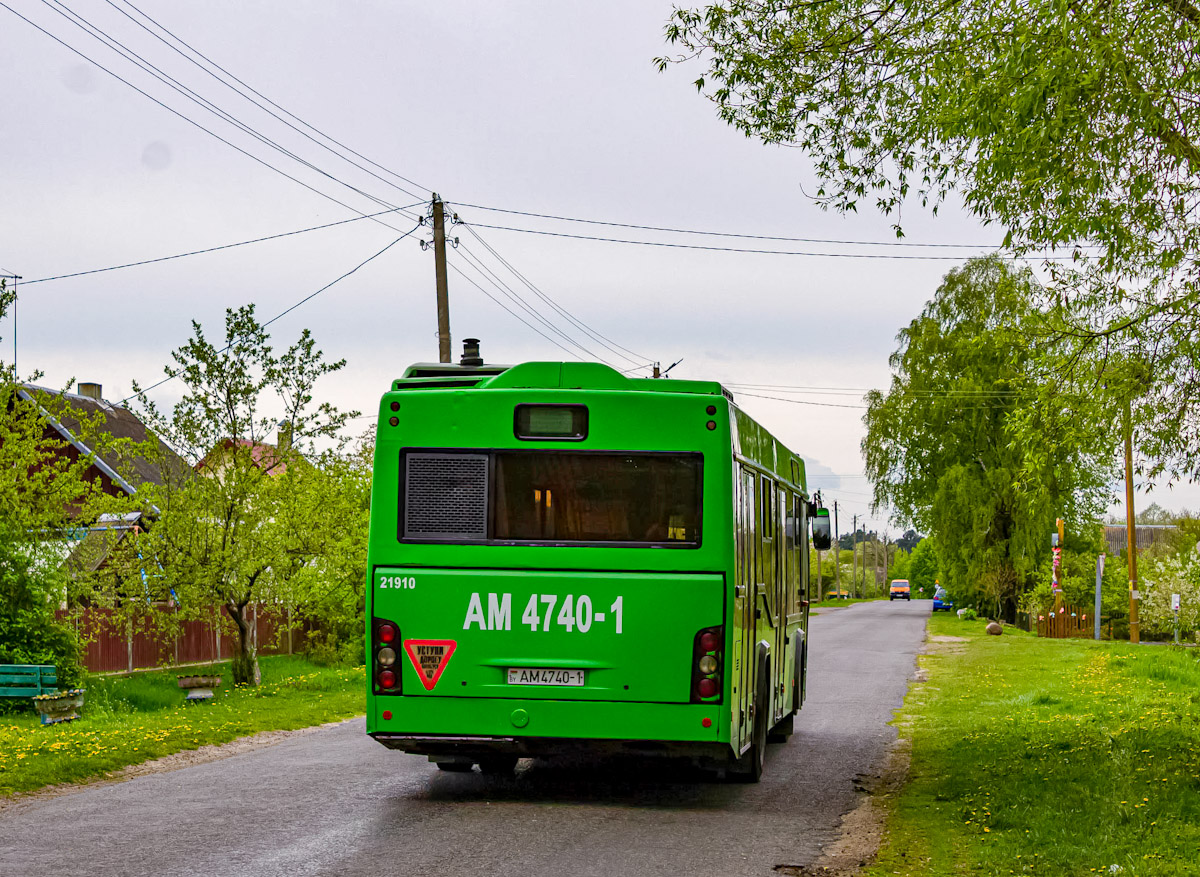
[{"left": 0, "top": 601, "right": 930, "bottom": 877}]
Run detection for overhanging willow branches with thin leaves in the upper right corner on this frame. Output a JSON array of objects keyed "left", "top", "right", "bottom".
[{"left": 658, "top": 0, "right": 1200, "bottom": 476}]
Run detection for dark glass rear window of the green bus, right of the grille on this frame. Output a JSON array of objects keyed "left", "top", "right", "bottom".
[{"left": 492, "top": 451, "right": 701, "bottom": 545}]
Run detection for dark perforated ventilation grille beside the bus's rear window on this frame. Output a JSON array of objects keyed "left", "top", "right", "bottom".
[{"left": 404, "top": 453, "right": 487, "bottom": 539}]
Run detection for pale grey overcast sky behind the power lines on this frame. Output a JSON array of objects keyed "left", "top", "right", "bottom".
[{"left": 0, "top": 0, "right": 1200, "bottom": 534}]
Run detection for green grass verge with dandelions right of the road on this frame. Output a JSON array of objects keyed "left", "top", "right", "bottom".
[{"left": 868, "top": 615, "right": 1200, "bottom": 877}]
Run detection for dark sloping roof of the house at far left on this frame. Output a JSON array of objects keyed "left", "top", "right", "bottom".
[{"left": 17, "top": 384, "right": 188, "bottom": 494}]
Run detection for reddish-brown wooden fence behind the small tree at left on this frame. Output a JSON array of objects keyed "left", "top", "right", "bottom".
[{"left": 59, "top": 606, "right": 307, "bottom": 673}]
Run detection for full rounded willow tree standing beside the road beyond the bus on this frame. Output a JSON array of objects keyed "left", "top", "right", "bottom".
[{"left": 863, "top": 257, "right": 1114, "bottom": 615}]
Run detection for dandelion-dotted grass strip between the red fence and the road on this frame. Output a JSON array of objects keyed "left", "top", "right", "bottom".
[{"left": 0, "top": 656, "right": 365, "bottom": 797}]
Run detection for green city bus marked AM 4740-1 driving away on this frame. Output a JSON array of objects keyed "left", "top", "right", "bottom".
[{"left": 366, "top": 350, "right": 828, "bottom": 781}]
